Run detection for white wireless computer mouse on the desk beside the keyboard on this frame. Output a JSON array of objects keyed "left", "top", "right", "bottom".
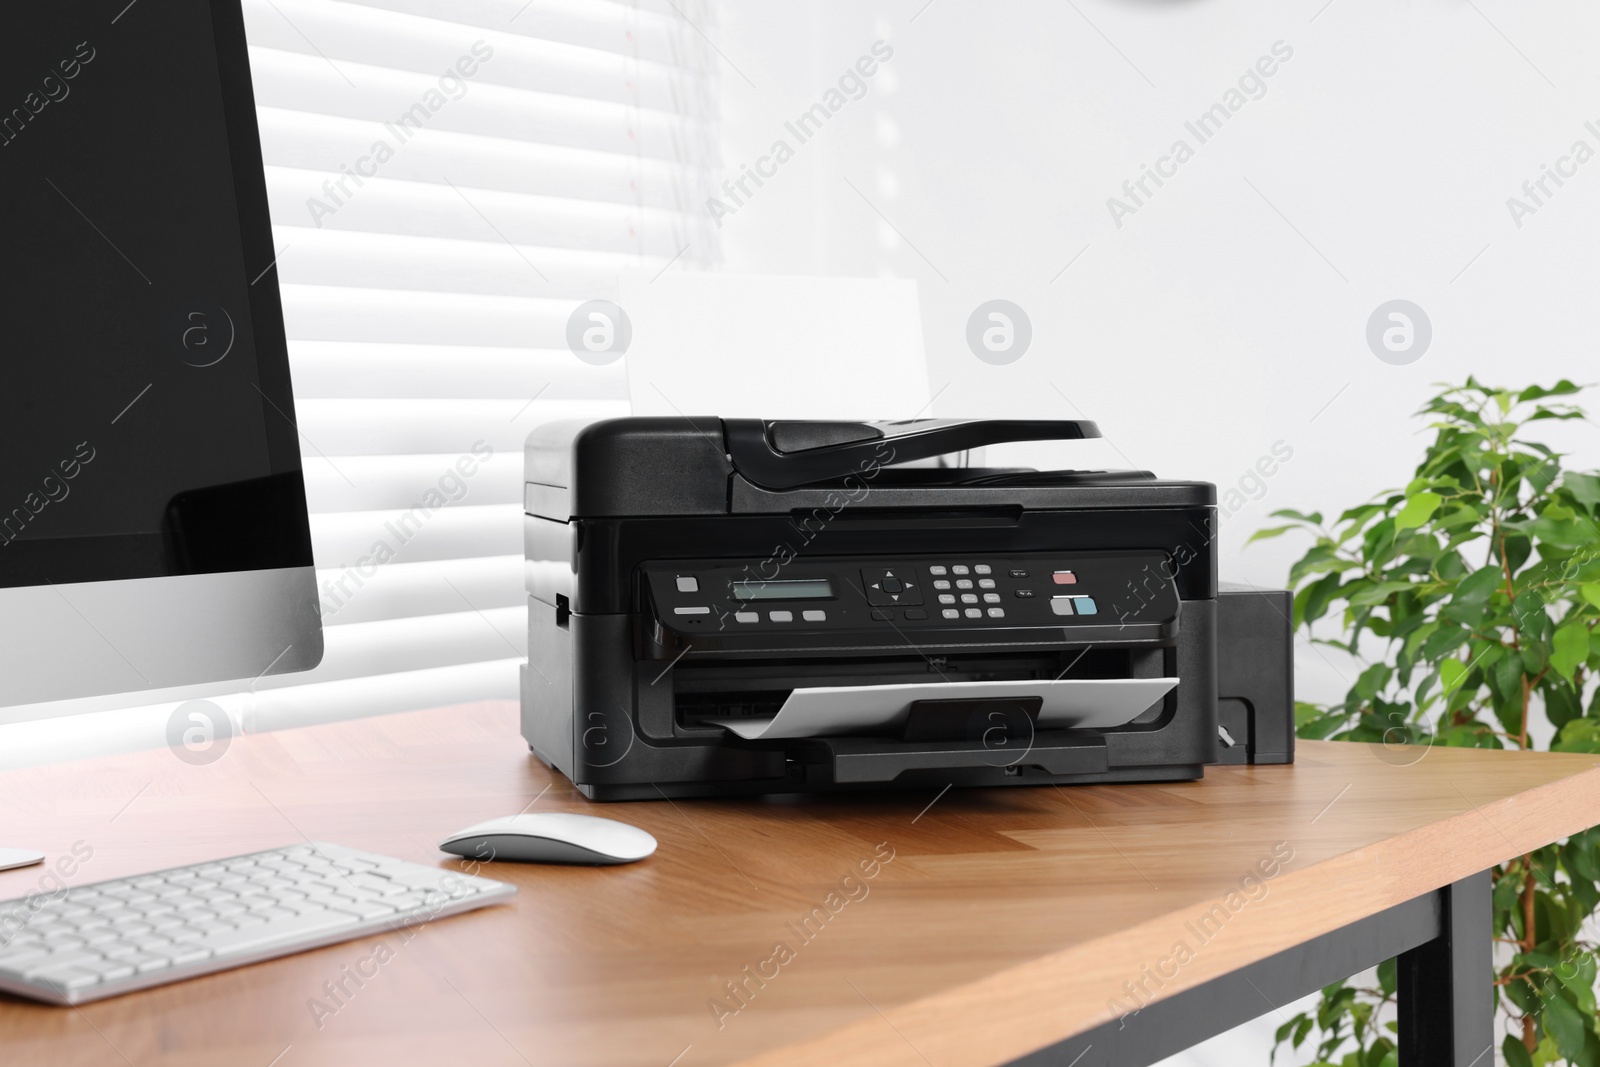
[{"left": 438, "top": 811, "right": 656, "bottom": 864}]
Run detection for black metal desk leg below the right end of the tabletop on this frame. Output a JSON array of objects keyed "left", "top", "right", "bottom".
[{"left": 1398, "top": 870, "right": 1494, "bottom": 1067}]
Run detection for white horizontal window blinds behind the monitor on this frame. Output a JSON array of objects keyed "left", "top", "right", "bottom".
[{"left": 0, "top": 0, "right": 717, "bottom": 765}]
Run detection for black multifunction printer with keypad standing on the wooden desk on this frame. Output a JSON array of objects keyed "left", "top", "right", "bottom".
[{"left": 522, "top": 416, "right": 1294, "bottom": 800}]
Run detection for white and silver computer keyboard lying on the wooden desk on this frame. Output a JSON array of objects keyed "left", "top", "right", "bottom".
[{"left": 0, "top": 843, "right": 517, "bottom": 1005}]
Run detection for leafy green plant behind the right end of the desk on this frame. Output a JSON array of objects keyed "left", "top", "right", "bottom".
[{"left": 1251, "top": 378, "right": 1600, "bottom": 1067}]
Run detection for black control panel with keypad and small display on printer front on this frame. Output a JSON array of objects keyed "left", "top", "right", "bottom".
[{"left": 642, "top": 550, "right": 1178, "bottom": 637}]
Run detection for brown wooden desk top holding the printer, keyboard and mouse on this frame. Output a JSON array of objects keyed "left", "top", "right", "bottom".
[{"left": 0, "top": 704, "right": 1600, "bottom": 1067}]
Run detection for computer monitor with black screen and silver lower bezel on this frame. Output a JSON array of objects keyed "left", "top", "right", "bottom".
[{"left": 0, "top": 0, "right": 322, "bottom": 716}]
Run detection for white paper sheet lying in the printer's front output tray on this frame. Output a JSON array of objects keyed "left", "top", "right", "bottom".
[{"left": 707, "top": 678, "right": 1178, "bottom": 741}]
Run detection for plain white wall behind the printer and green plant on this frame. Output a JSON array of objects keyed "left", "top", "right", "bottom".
[{"left": 717, "top": 0, "right": 1600, "bottom": 1064}]
